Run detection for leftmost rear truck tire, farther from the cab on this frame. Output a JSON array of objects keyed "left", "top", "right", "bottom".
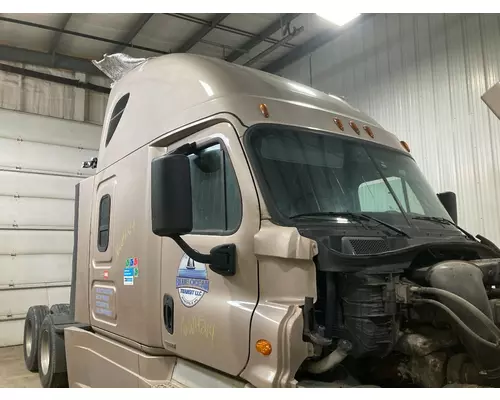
[{"left": 23, "top": 305, "right": 49, "bottom": 372}]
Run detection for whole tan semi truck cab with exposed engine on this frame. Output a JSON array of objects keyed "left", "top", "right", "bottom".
[{"left": 25, "top": 54, "right": 500, "bottom": 387}]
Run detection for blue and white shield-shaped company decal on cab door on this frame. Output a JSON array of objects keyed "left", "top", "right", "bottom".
[{"left": 175, "top": 254, "right": 209, "bottom": 307}]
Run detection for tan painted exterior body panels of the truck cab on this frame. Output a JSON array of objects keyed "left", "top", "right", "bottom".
[{"left": 65, "top": 54, "right": 401, "bottom": 387}]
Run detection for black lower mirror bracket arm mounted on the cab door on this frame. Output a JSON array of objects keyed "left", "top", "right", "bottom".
[{"left": 171, "top": 235, "right": 236, "bottom": 276}]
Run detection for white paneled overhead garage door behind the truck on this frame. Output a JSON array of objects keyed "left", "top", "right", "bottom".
[{"left": 0, "top": 110, "right": 101, "bottom": 347}]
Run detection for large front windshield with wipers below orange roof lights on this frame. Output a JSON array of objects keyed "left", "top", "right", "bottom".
[{"left": 249, "top": 126, "right": 450, "bottom": 223}]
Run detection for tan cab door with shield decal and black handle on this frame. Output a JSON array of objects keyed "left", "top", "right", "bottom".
[{"left": 161, "top": 123, "right": 260, "bottom": 375}]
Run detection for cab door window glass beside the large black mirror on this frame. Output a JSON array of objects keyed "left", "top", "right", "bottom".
[{"left": 189, "top": 144, "right": 242, "bottom": 233}]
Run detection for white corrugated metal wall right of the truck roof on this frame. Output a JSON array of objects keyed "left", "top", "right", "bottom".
[{"left": 280, "top": 14, "right": 500, "bottom": 244}]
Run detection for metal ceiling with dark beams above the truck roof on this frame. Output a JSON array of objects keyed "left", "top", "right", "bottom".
[{"left": 0, "top": 14, "right": 366, "bottom": 75}]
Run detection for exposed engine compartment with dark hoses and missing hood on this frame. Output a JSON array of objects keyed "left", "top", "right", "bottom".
[{"left": 296, "top": 228, "right": 500, "bottom": 387}]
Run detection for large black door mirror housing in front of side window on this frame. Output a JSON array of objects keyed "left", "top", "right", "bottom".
[{"left": 151, "top": 154, "right": 193, "bottom": 237}]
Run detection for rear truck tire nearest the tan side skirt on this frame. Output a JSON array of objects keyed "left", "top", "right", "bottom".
[{"left": 38, "top": 314, "right": 68, "bottom": 388}]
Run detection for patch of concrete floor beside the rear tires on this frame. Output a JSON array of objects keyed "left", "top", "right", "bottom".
[{"left": 0, "top": 346, "right": 41, "bottom": 388}]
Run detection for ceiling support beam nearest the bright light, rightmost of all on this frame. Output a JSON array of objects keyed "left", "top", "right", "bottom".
[{"left": 262, "top": 14, "right": 373, "bottom": 74}]
